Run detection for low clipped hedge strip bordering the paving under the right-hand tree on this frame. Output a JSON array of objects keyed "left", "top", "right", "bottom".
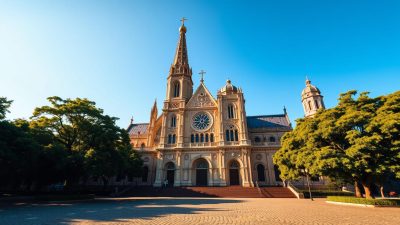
[{"left": 326, "top": 196, "right": 400, "bottom": 206}]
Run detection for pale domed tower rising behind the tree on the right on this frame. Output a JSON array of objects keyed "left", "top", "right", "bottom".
[{"left": 301, "top": 78, "right": 325, "bottom": 117}]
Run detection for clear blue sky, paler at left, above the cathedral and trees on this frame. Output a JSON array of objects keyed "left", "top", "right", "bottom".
[{"left": 0, "top": 0, "right": 400, "bottom": 127}]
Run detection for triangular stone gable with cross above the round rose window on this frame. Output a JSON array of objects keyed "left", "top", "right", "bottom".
[{"left": 187, "top": 83, "right": 217, "bottom": 108}]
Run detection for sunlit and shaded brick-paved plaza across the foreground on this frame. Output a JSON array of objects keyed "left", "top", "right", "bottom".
[{"left": 0, "top": 198, "right": 400, "bottom": 225}]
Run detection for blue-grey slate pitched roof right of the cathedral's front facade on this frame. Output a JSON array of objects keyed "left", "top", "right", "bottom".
[{"left": 247, "top": 114, "right": 292, "bottom": 129}]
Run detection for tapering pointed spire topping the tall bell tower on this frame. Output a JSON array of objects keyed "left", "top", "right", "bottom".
[{"left": 170, "top": 17, "right": 191, "bottom": 75}]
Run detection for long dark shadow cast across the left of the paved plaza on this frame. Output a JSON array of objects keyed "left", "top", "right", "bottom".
[{"left": 0, "top": 198, "right": 243, "bottom": 225}]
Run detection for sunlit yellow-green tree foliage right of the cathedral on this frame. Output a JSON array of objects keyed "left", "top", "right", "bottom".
[{"left": 274, "top": 91, "right": 400, "bottom": 199}]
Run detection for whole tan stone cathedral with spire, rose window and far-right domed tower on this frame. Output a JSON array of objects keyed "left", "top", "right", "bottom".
[{"left": 128, "top": 20, "right": 324, "bottom": 187}]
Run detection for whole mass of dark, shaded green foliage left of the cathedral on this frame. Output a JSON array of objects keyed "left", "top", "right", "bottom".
[{"left": 0, "top": 97, "right": 142, "bottom": 190}]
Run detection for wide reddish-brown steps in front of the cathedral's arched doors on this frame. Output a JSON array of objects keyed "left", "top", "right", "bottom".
[{"left": 122, "top": 186, "right": 295, "bottom": 198}]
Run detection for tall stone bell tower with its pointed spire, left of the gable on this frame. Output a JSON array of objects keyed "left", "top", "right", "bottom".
[{"left": 164, "top": 18, "right": 193, "bottom": 105}]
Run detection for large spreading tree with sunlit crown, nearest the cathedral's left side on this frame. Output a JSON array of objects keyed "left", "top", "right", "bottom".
[{"left": 32, "top": 96, "right": 141, "bottom": 185}]
